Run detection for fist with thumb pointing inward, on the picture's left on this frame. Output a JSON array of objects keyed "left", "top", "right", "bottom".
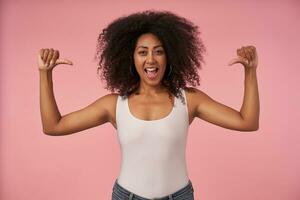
[{"left": 38, "top": 49, "right": 73, "bottom": 71}]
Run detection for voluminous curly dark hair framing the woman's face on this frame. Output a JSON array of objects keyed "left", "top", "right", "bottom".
[{"left": 96, "top": 10, "right": 206, "bottom": 102}]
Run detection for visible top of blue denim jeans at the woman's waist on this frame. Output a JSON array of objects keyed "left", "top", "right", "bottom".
[{"left": 113, "top": 179, "right": 194, "bottom": 200}]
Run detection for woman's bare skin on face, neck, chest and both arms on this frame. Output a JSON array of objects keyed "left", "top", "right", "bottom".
[{"left": 38, "top": 34, "right": 259, "bottom": 136}]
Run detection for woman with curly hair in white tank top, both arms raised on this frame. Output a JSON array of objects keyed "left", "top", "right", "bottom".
[{"left": 38, "top": 11, "right": 259, "bottom": 200}]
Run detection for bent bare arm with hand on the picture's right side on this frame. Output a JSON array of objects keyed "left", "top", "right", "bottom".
[{"left": 195, "top": 46, "right": 259, "bottom": 131}]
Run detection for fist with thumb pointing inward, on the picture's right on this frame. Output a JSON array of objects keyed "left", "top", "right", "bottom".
[{"left": 228, "top": 46, "right": 258, "bottom": 69}]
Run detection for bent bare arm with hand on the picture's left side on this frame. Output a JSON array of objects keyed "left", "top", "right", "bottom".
[{"left": 38, "top": 49, "right": 114, "bottom": 136}]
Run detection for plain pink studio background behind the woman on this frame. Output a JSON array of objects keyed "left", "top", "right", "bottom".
[{"left": 0, "top": 0, "right": 300, "bottom": 200}]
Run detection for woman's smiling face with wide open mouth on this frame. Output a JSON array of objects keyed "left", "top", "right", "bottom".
[{"left": 134, "top": 33, "right": 167, "bottom": 85}]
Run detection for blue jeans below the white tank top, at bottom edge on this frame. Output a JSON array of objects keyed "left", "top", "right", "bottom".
[{"left": 112, "top": 180, "right": 194, "bottom": 200}]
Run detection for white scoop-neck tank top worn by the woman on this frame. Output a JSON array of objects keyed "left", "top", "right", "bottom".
[{"left": 116, "top": 89, "right": 189, "bottom": 198}]
